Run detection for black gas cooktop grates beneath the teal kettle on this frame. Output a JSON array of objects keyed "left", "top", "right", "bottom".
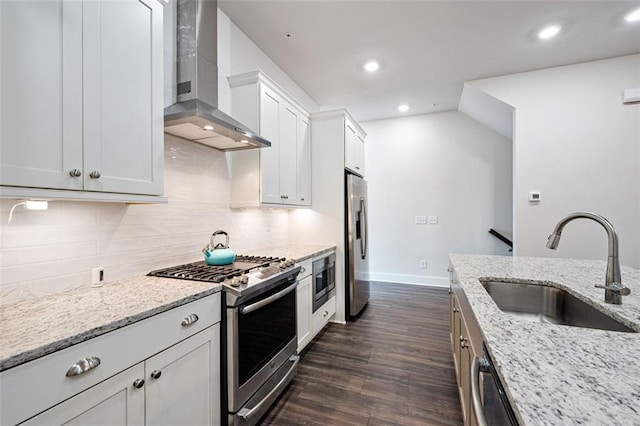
[{"left": 147, "top": 256, "right": 289, "bottom": 284}]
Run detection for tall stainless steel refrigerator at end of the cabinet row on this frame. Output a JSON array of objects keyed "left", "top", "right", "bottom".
[{"left": 345, "top": 173, "right": 369, "bottom": 319}]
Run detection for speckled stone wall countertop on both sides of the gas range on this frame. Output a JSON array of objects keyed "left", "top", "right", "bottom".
[{"left": 0, "top": 245, "right": 335, "bottom": 371}]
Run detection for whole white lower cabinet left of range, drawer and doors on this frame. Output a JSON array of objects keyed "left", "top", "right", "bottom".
[{"left": 0, "top": 293, "right": 222, "bottom": 426}]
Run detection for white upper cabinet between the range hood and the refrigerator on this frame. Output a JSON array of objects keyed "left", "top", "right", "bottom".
[{"left": 229, "top": 71, "right": 311, "bottom": 207}]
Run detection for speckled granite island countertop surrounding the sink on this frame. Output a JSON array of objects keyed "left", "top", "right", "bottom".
[{"left": 449, "top": 254, "right": 640, "bottom": 425}]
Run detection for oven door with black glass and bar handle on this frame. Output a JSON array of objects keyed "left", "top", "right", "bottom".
[{"left": 227, "top": 277, "right": 298, "bottom": 417}]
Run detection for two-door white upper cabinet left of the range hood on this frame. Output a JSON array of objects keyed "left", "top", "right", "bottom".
[{"left": 0, "top": 0, "right": 164, "bottom": 201}]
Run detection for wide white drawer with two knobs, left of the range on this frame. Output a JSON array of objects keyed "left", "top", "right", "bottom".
[{"left": 0, "top": 293, "right": 221, "bottom": 425}]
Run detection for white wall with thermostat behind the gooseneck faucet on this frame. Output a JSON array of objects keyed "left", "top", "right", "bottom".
[{"left": 470, "top": 55, "right": 640, "bottom": 268}]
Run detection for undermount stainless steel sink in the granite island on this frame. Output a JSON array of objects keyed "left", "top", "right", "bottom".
[{"left": 480, "top": 280, "right": 636, "bottom": 333}]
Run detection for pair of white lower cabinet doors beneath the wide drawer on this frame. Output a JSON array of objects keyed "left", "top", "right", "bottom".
[{"left": 25, "top": 324, "right": 220, "bottom": 426}]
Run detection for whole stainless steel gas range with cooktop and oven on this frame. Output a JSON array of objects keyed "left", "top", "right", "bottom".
[{"left": 148, "top": 256, "right": 300, "bottom": 425}]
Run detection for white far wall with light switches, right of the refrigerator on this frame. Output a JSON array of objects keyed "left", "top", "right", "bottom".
[{"left": 361, "top": 111, "right": 512, "bottom": 285}]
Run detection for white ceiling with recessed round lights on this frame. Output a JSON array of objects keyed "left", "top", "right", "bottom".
[{"left": 218, "top": 0, "right": 640, "bottom": 121}]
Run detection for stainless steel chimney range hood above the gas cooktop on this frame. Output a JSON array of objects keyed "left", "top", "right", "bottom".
[{"left": 164, "top": 0, "right": 271, "bottom": 151}]
